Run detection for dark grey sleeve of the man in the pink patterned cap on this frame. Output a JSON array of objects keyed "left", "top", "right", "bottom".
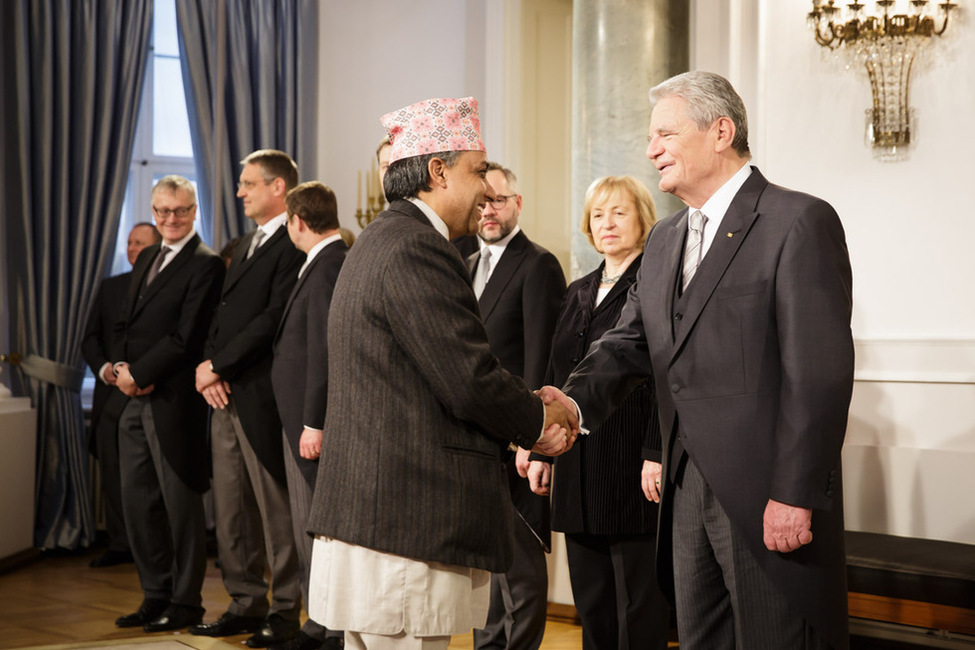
[{"left": 382, "top": 230, "right": 544, "bottom": 448}]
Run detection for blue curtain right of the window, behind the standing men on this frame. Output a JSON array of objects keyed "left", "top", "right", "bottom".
[{"left": 176, "top": 0, "right": 319, "bottom": 248}]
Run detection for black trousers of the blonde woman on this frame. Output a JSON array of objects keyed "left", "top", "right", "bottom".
[{"left": 565, "top": 533, "right": 670, "bottom": 650}]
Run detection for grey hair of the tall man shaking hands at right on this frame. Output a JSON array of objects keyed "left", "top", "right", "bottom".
[{"left": 650, "top": 71, "right": 752, "bottom": 158}]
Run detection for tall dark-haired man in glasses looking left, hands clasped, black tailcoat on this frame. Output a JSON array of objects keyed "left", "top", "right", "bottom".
[{"left": 190, "top": 149, "right": 305, "bottom": 648}]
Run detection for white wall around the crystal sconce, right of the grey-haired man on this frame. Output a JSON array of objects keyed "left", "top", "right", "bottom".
[{"left": 692, "top": 0, "right": 975, "bottom": 543}]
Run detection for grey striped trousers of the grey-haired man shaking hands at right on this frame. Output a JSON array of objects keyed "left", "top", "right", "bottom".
[{"left": 673, "top": 459, "right": 829, "bottom": 650}]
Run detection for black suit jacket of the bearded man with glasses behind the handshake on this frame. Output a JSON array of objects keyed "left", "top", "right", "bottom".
[{"left": 467, "top": 231, "right": 565, "bottom": 550}]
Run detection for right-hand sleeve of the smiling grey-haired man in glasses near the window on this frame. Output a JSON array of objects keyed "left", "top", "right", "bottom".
[{"left": 129, "top": 255, "right": 225, "bottom": 388}]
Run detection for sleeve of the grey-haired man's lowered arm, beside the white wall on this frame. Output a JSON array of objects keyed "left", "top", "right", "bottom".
[{"left": 770, "top": 201, "right": 853, "bottom": 508}]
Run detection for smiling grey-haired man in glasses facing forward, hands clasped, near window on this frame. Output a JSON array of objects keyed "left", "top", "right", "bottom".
[{"left": 111, "top": 176, "right": 224, "bottom": 632}]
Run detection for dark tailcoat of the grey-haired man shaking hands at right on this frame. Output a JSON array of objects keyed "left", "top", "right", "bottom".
[{"left": 565, "top": 169, "right": 853, "bottom": 648}]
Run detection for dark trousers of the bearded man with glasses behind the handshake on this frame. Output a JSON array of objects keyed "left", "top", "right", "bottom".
[{"left": 474, "top": 509, "right": 548, "bottom": 650}]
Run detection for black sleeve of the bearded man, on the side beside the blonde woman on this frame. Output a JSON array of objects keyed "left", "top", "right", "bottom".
[{"left": 521, "top": 252, "right": 565, "bottom": 390}]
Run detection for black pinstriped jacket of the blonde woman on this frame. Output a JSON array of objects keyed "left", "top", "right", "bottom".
[{"left": 533, "top": 257, "right": 662, "bottom": 535}]
